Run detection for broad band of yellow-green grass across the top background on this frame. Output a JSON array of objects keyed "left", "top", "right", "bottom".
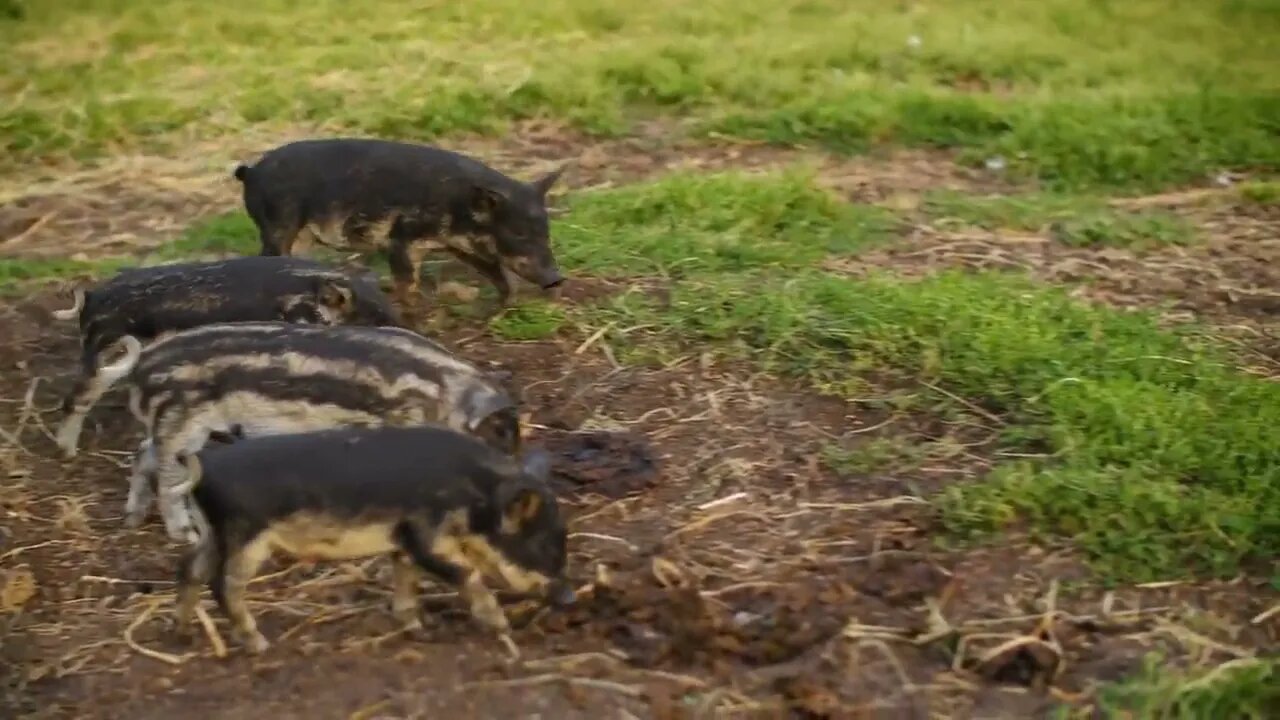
[{"left": 0, "top": 0, "right": 1280, "bottom": 188}]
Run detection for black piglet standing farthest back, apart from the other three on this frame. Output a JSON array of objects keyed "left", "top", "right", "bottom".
[{"left": 234, "top": 137, "right": 564, "bottom": 305}]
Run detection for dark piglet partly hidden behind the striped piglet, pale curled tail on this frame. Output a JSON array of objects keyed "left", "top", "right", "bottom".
[{"left": 54, "top": 256, "right": 401, "bottom": 456}]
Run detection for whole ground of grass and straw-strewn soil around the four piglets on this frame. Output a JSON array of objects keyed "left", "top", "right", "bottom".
[{"left": 0, "top": 0, "right": 1280, "bottom": 719}]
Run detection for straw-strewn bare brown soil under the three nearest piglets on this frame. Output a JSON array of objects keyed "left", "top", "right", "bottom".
[{"left": 0, "top": 286, "right": 1280, "bottom": 717}]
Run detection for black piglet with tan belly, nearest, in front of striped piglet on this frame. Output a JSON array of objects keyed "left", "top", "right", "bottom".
[{"left": 178, "top": 425, "right": 575, "bottom": 653}]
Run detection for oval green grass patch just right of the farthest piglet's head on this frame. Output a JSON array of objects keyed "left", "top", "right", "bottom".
[{"left": 552, "top": 169, "right": 897, "bottom": 277}]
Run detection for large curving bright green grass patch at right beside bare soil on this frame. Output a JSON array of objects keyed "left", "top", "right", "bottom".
[{"left": 586, "top": 272, "right": 1280, "bottom": 579}]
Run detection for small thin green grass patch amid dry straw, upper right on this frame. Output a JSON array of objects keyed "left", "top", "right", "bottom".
[{"left": 924, "top": 192, "right": 1196, "bottom": 250}]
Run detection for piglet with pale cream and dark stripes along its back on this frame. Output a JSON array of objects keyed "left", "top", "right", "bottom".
[{"left": 110, "top": 322, "right": 520, "bottom": 541}]
